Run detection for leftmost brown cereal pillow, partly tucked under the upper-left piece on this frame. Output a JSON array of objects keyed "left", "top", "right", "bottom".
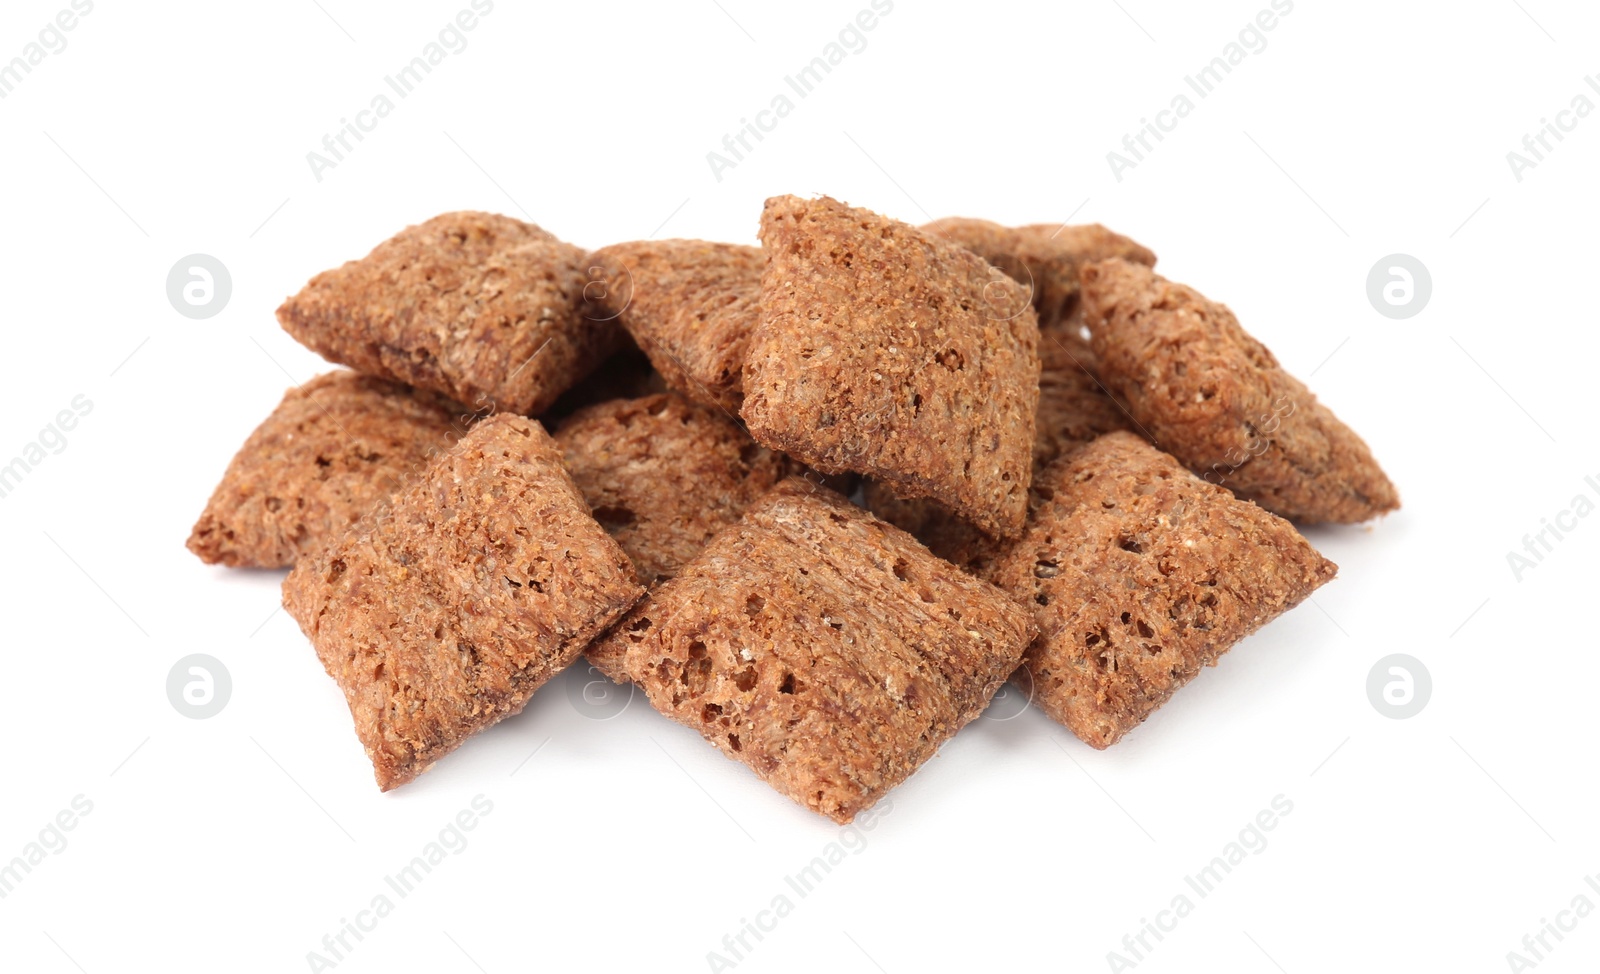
[{"left": 189, "top": 371, "right": 472, "bottom": 568}]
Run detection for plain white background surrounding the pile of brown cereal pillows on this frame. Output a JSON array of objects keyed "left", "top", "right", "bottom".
[{"left": 0, "top": 0, "right": 1600, "bottom": 974}]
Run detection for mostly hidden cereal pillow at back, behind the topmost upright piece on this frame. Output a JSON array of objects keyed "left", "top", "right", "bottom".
[{"left": 922, "top": 216, "right": 1155, "bottom": 328}]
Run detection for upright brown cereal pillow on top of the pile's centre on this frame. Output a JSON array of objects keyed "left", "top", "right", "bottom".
[{"left": 742, "top": 197, "right": 1038, "bottom": 536}]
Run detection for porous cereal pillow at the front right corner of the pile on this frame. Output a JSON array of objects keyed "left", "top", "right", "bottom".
[{"left": 987, "top": 432, "right": 1338, "bottom": 748}]
